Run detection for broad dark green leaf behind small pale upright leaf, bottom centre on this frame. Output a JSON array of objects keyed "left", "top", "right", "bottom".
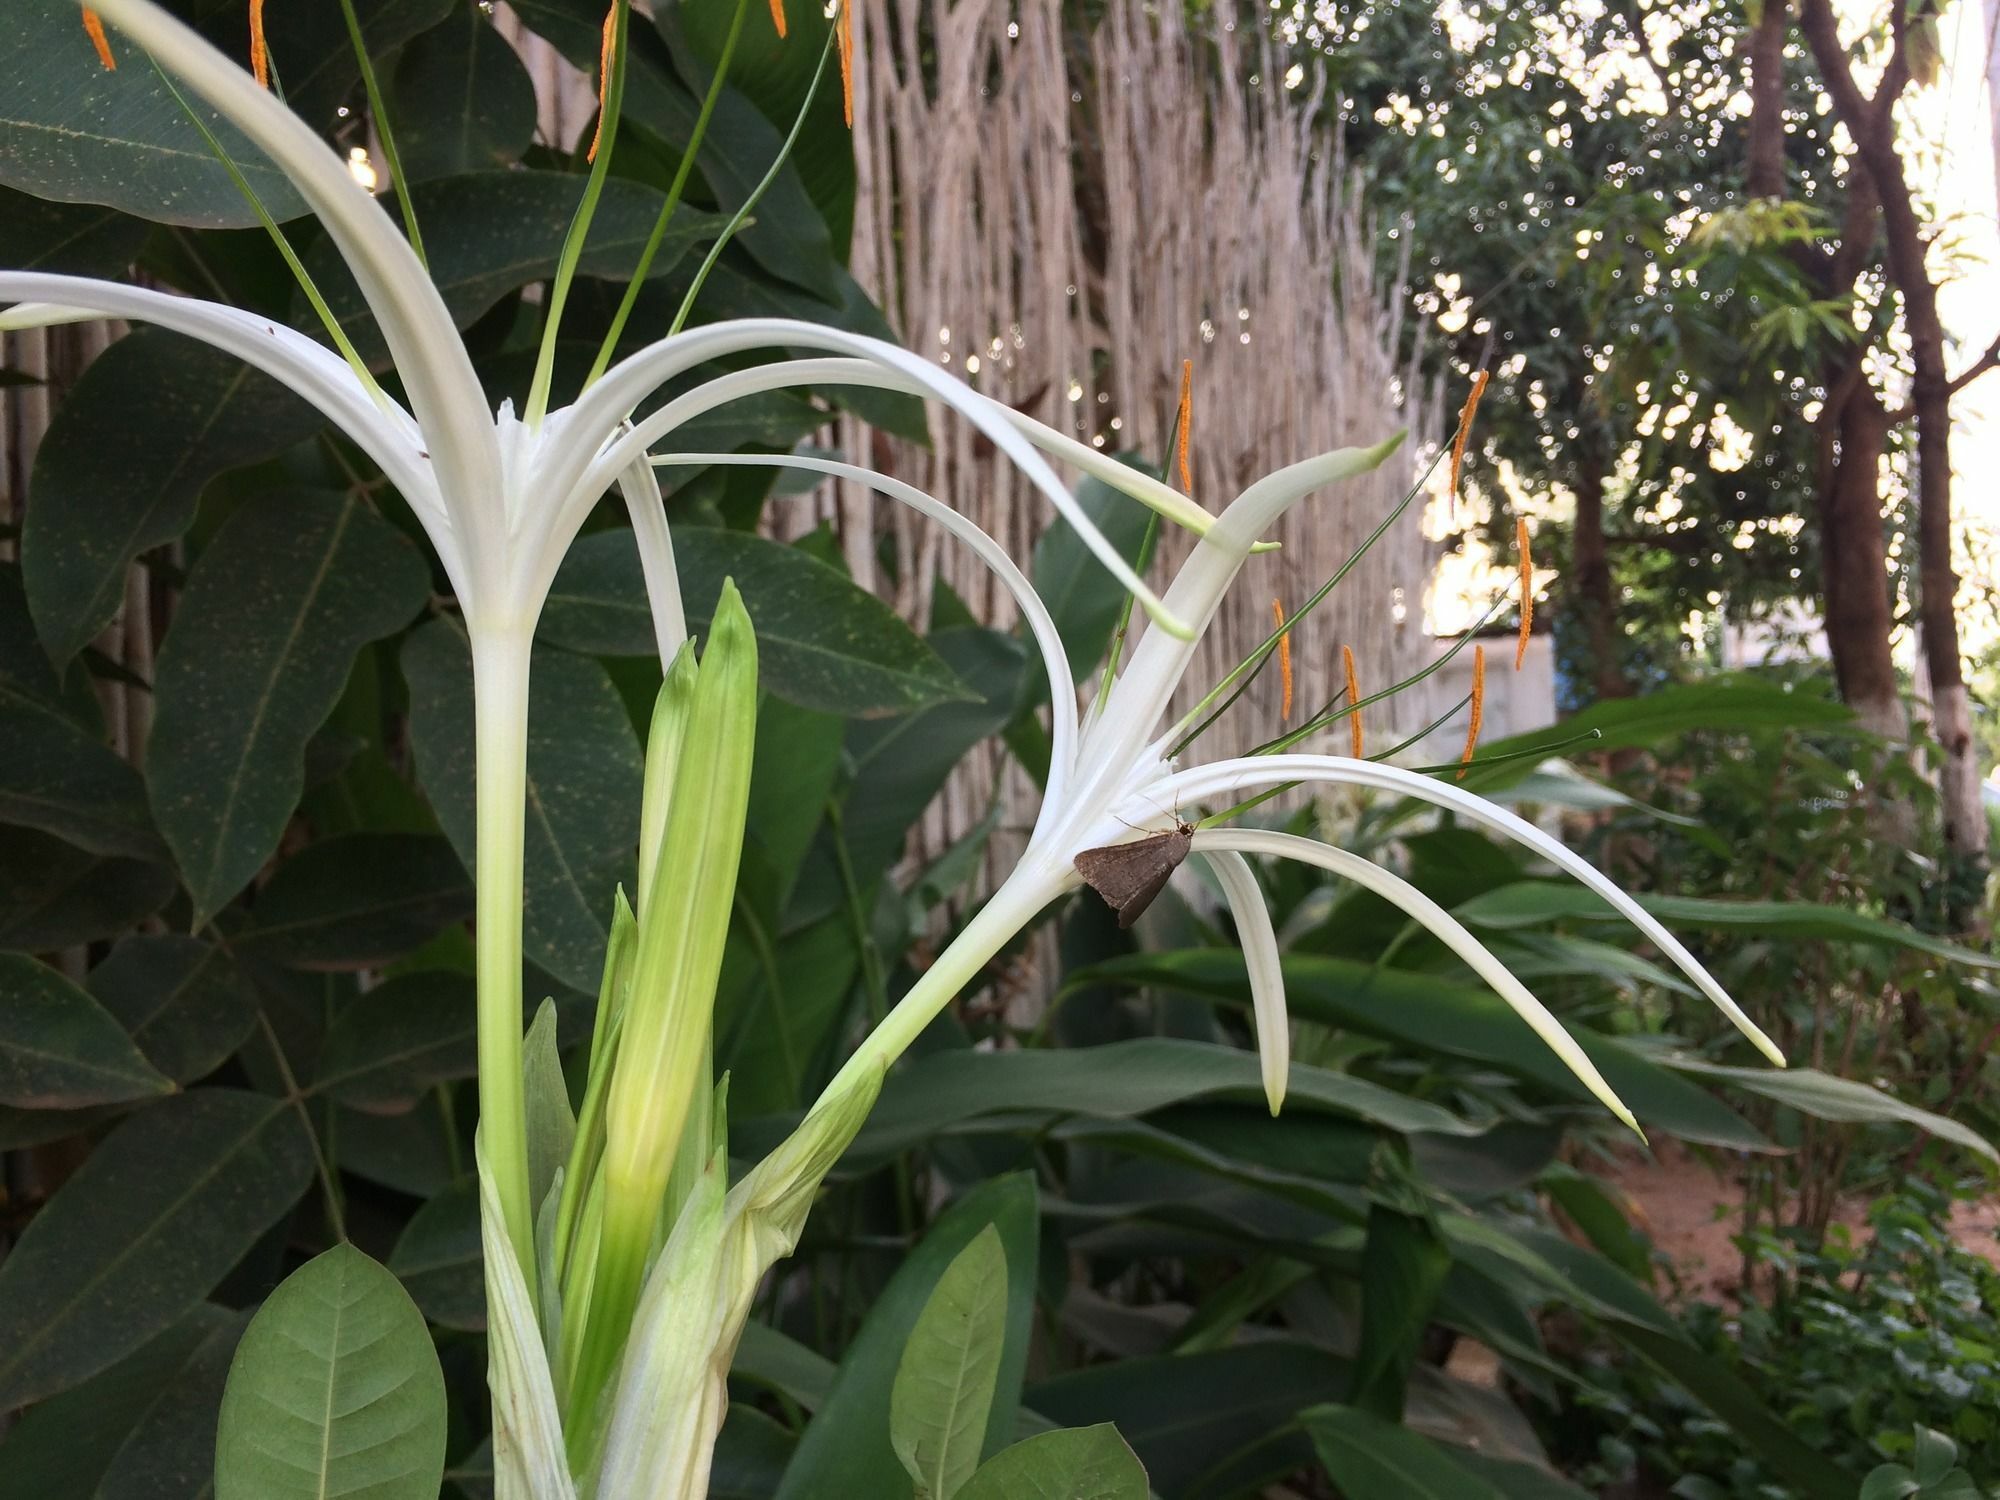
[{"left": 776, "top": 1176, "right": 1040, "bottom": 1500}]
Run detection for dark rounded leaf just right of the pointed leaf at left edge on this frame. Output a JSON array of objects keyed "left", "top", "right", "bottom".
[{"left": 86, "top": 934, "right": 258, "bottom": 1084}]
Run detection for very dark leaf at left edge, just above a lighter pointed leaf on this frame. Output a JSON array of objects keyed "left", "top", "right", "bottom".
[{"left": 0, "top": 828, "right": 178, "bottom": 954}]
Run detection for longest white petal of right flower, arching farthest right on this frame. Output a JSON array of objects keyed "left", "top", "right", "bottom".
[{"left": 1152, "top": 756, "right": 1784, "bottom": 1068}]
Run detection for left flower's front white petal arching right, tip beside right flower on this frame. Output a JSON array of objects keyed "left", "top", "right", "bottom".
[{"left": 572, "top": 318, "right": 1192, "bottom": 636}]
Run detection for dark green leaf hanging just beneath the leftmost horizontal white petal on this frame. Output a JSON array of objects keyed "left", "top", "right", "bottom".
[{"left": 23, "top": 332, "right": 322, "bottom": 662}]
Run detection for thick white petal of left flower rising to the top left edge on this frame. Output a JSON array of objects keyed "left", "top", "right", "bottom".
[{"left": 92, "top": 0, "right": 500, "bottom": 524}]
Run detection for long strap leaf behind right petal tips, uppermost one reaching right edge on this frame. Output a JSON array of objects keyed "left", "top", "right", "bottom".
[{"left": 1458, "top": 880, "right": 2000, "bottom": 968}]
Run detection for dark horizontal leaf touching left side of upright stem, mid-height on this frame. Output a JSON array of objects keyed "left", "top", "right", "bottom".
[{"left": 238, "top": 832, "right": 472, "bottom": 970}]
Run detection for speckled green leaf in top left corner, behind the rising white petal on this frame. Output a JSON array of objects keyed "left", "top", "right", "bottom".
[{"left": 0, "top": 0, "right": 310, "bottom": 228}]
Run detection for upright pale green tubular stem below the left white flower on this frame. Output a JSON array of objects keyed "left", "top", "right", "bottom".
[{"left": 472, "top": 630, "right": 536, "bottom": 1300}]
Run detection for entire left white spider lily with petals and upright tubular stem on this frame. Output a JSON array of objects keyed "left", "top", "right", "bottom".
[{"left": 0, "top": 0, "right": 1210, "bottom": 1300}]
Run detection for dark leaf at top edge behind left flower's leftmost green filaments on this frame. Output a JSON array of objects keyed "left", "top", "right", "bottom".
[{"left": 390, "top": 6, "right": 534, "bottom": 180}]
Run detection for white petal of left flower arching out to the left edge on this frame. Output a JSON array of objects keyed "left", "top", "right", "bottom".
[{"left": 0, "top": 270, "right": 466, "bottom": 590}]
